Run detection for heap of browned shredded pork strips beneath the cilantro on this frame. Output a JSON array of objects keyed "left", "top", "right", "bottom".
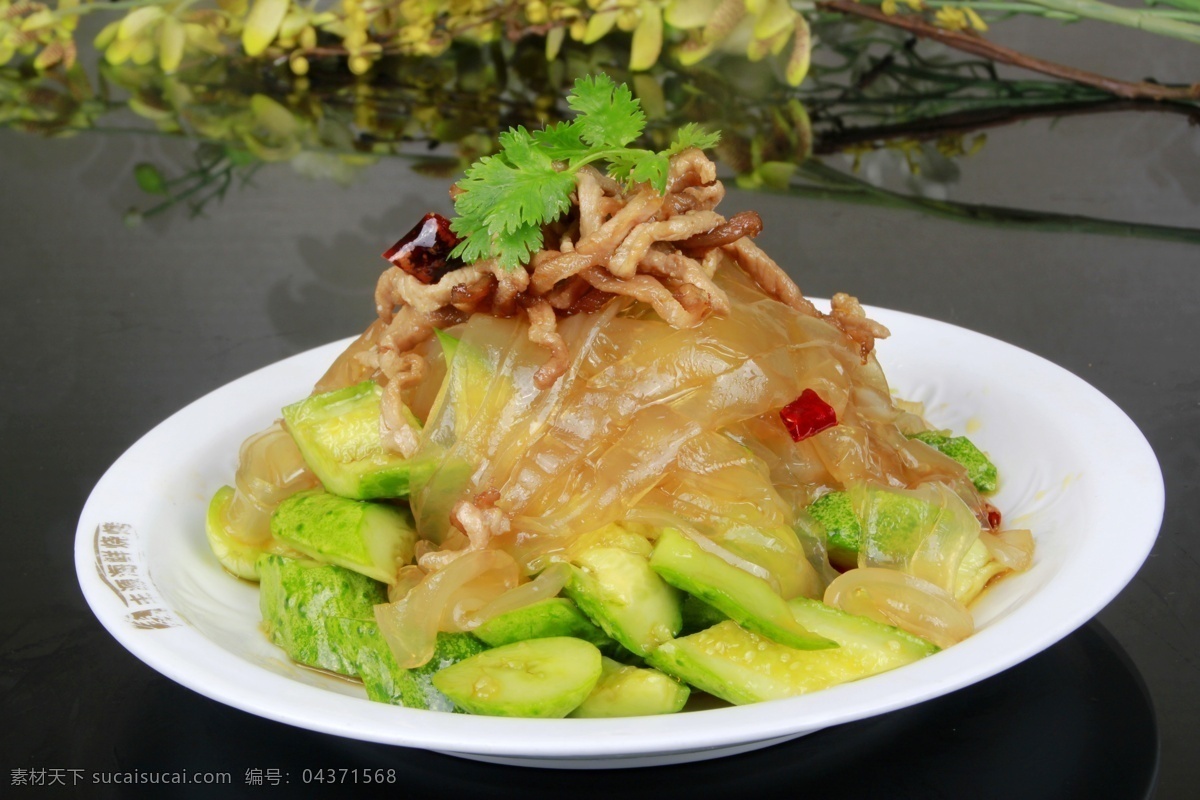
[{"left": 333, "top": 149, "right": 888, "bottom": 431}]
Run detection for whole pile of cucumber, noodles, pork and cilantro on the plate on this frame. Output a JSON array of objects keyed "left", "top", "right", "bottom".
[{"left": 206, "top": 76, "right": 1033, "bottom": 717}]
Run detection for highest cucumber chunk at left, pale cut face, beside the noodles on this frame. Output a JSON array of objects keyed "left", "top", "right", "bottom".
[{"left": 283, "top": 380, "right": 433, "bottom": 500}]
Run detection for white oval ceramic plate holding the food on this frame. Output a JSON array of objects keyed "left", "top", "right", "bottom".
[{"left": 76, "top": 308, "right": 1163, "bottom": 768}]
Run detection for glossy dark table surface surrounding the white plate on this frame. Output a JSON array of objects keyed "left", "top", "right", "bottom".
[{"left": 0, "top": 18, "right": 1200, "bottom": 799}]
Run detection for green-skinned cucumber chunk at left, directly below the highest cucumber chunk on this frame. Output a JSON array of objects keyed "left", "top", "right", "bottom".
[{"left": 271, "top": 491, "right": 416, "bottom": 584}]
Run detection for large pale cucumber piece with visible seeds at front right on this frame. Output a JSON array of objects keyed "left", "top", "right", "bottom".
[{"left": 647, "top": 614, "right": 936, "bottom": 705}]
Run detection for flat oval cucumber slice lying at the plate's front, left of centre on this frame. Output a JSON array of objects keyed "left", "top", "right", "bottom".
[{"left": 433, "top": 637, "right": 601, "bottom": 718}]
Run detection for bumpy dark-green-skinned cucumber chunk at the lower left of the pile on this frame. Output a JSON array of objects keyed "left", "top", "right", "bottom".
[{"left": 258, "top": 554, "right": 388, "bottom": 675}]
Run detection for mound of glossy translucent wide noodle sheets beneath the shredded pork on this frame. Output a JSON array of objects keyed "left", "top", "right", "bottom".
[{"left": 400, "top": 271, "right": 993, "bottom": 642}]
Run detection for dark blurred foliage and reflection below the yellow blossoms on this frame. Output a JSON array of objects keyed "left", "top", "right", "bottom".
[{"left": 0, "top": 0, "right": 1200, "bottom": 241}]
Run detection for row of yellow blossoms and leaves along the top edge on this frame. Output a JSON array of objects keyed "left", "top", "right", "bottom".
[{"left": 9, "top": 0, "right": 849, "bottom": 85}]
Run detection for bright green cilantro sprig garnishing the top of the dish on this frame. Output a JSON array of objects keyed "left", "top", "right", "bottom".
[{"left": 450, "top": 74, "right": 720, "bottom": 270}]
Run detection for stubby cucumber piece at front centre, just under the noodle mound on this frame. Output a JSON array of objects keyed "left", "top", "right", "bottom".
[{"left": 564, "top": 547, "right": 683, "bottom": 656}]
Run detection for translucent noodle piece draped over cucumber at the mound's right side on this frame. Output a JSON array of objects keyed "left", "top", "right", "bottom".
[{"left": 850, "top": 483, "right": 980, "bottom": 594}]
